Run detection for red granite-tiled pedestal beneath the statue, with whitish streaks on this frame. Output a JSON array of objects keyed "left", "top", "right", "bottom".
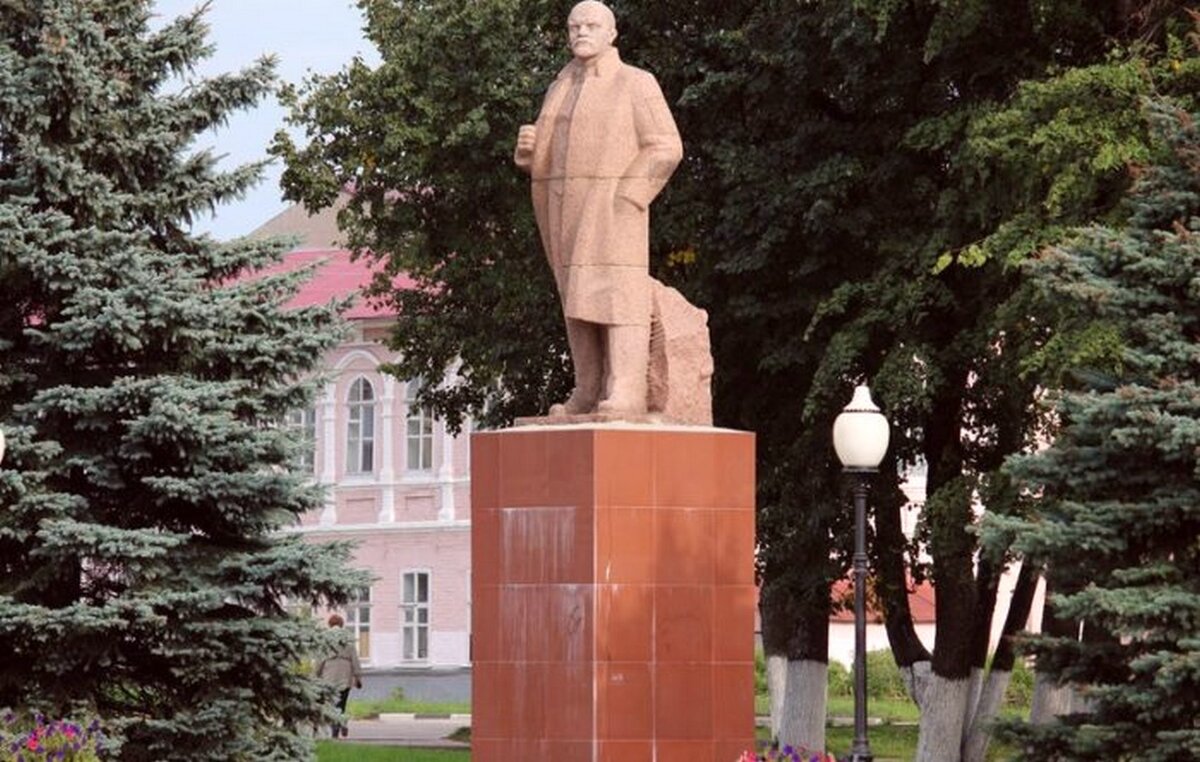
[{"left": 472, "top": 424, "right": 755, "bottom": 762}]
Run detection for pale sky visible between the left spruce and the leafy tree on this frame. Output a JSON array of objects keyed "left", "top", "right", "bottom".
[{"left": 155, "top": 0, "right": 378, "bottom": 240}]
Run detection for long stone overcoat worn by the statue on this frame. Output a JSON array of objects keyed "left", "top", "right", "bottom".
[{"left": 517, "top": 48, "right": 683, "bottom": 325}]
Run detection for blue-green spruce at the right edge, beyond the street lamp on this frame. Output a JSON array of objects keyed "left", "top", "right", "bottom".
[{"left": 996, "top": 102, "right": 1200, "bottom": 761}]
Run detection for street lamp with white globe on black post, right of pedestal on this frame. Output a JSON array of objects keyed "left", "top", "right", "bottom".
[{"left": 833, "top": 385, "right": 889, "bottom": 762}]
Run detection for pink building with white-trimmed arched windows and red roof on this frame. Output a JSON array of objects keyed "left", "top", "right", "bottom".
[{"left": 251, "top": 201, "right": 470, "bottom": 671}]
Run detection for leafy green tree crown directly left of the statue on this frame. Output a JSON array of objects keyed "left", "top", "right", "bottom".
[{"left": 272, "top": 0, "right": 569, "bottom": 426}]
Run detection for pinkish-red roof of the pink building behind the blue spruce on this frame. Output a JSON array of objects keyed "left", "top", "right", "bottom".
[{"left": 247, "top": 248, "right": 415, "bottom": 320}]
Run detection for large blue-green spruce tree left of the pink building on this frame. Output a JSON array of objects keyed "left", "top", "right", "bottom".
[{"left": 0, "top": 0, "right": 359, "bottom": 762}]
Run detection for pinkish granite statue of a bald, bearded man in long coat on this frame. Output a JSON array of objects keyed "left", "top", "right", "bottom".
[{"left": 512, "top": 0, "right": 712, "bottom": 424}]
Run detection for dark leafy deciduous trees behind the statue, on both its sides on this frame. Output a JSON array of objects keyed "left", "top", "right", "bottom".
[{"left": 276, "top": 0, "right": 1196, "bottom": 748}]
